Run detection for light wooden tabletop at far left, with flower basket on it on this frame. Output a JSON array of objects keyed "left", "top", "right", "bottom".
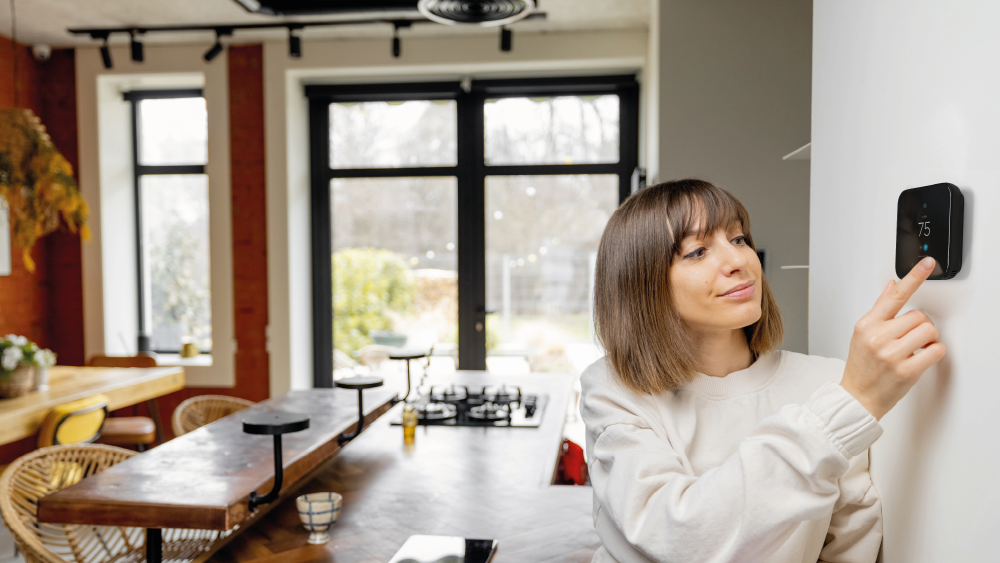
[{"left": 0, "top": 366, "right": 184, "bottom": 445}]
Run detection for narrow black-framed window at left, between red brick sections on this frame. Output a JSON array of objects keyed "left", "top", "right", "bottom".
[{"left": 125, "top": 90, "right": 212, "bottom": 353}]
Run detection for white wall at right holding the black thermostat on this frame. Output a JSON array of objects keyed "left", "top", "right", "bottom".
[{"left": 809, "top": 0, "right": 1000, "bottom": 563}]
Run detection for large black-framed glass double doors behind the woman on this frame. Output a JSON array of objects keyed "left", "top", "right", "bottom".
[{"left": 306, "top": 76, "right": 638, "bottom": 387}]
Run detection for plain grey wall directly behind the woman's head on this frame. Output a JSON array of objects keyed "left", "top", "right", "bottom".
[{"left": 650, "top": 0, "right": 812, "bottom": 352}]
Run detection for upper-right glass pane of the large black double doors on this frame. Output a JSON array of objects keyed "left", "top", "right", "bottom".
[{"left": 484, "top": 95, "right": 620, "bottom": 165}]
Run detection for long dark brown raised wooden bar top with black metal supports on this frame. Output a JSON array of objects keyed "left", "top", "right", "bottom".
[{"left": 38, "top": 388, "right": 396, "bottom": 563}]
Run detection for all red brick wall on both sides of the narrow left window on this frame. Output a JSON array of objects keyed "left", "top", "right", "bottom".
[{"left": 0, "top": 36, "right": 270, "bottom": 458}]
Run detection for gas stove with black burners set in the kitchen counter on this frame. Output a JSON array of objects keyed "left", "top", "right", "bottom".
[{"left": 392, "top": 385, "right": 549, "bottom": 428}]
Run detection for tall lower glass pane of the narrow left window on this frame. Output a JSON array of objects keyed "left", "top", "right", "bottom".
[{"left": 139, "top": 174, "right": 212, "bottom": 352}]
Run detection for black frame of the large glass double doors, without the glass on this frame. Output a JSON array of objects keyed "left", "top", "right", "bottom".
[{"left": 305, "top": 74, "right": 639, "bottom": 388}]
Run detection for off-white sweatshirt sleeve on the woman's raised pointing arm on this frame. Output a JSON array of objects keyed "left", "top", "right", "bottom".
[{"left": 583, "top": 383, "right": 882, "bottom": 563}]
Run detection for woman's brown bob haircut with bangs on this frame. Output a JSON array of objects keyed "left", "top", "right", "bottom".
[{"left": 594, "top": 179, "right": 782, "bottom": 394}]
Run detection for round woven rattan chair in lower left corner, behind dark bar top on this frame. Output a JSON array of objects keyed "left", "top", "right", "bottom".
[{"left": 0, "top": 444, "right": 228, "bottom": 563}]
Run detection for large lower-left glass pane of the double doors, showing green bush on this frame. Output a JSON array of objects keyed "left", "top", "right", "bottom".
[{"left": 330, "top": 177, "right": 458, "bottom": 357}]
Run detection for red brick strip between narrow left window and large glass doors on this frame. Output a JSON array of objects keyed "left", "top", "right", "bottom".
[{"left": 145, "top": 45, "right": 270, "bottom": 440}]
